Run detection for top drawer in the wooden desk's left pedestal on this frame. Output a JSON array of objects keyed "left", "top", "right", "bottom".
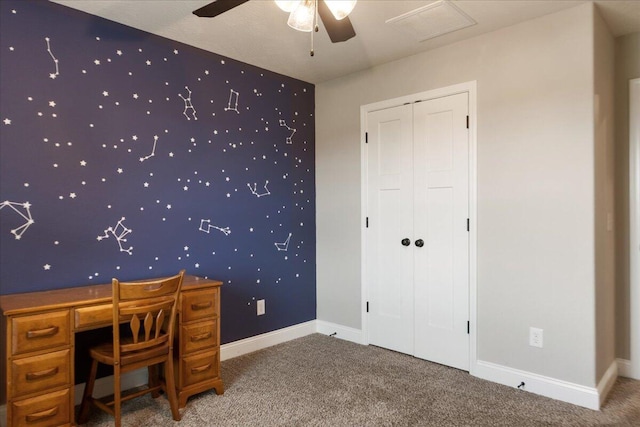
[{"left": 11, "top": 310, "right": 70, "bottom": 355}]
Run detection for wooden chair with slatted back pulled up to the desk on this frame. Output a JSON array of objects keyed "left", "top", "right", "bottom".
[{"left": 78, "top": 270, "right": 185, "bottom": 427}]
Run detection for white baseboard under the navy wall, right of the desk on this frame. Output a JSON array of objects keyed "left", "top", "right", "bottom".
[{"left": 220, "top": 320, "right": 316, "bottom": 360}]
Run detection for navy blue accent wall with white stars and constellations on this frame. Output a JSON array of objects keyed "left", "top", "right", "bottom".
[{"left": 0, "top": 0, "right": 316, "bottom": 342}]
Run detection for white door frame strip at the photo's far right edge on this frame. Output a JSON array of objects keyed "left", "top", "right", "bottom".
[{"left": 629, "top": 78, "right": 640, "bottom": 379}]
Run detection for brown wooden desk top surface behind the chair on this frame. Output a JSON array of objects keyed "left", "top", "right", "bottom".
[{"left": 0, "top": 276, "right": 222, "bottom": 316}]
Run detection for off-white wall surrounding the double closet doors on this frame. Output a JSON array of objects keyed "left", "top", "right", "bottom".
[{"left": 316, "top": 4, "right": 595, "bottom": 387}]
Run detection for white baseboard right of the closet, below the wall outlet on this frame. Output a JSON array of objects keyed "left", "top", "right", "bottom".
[{"left": 472, "top": 360, "right": 600, "bottom": 410}]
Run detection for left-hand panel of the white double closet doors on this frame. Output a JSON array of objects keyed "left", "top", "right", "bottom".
[{"left": 365, "top": 105, "right": 413, "bottom": 354}]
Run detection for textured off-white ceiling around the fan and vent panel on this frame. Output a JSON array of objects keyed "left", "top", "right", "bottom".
[{"left": 55, "top": 0, "right": 640, "bottom": 83}]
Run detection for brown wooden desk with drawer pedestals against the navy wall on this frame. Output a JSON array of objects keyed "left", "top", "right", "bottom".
[{"left": 0, "top": 276, "right": 224, "bottom": 427}]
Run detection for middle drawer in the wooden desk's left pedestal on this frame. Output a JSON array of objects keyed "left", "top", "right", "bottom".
[{"left": 11, "top": 349, "right": 71, "bottom": 397}]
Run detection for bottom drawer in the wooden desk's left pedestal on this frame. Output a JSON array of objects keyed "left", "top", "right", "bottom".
[{"left": 11, "top": 388, "right": 71, "bottom": 427}]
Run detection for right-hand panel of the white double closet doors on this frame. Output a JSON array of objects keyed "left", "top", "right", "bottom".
[{"left": 413, "top": 93, "right": 469, "bottom": 370}]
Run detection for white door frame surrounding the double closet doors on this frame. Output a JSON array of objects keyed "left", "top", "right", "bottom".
[{"left": 360, "top": 80, "right": 478, "bottom": 374}]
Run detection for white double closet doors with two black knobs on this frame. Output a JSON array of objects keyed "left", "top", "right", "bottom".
[{"left": 365, "top": 93, "right": 469, "bottom": 371}]
